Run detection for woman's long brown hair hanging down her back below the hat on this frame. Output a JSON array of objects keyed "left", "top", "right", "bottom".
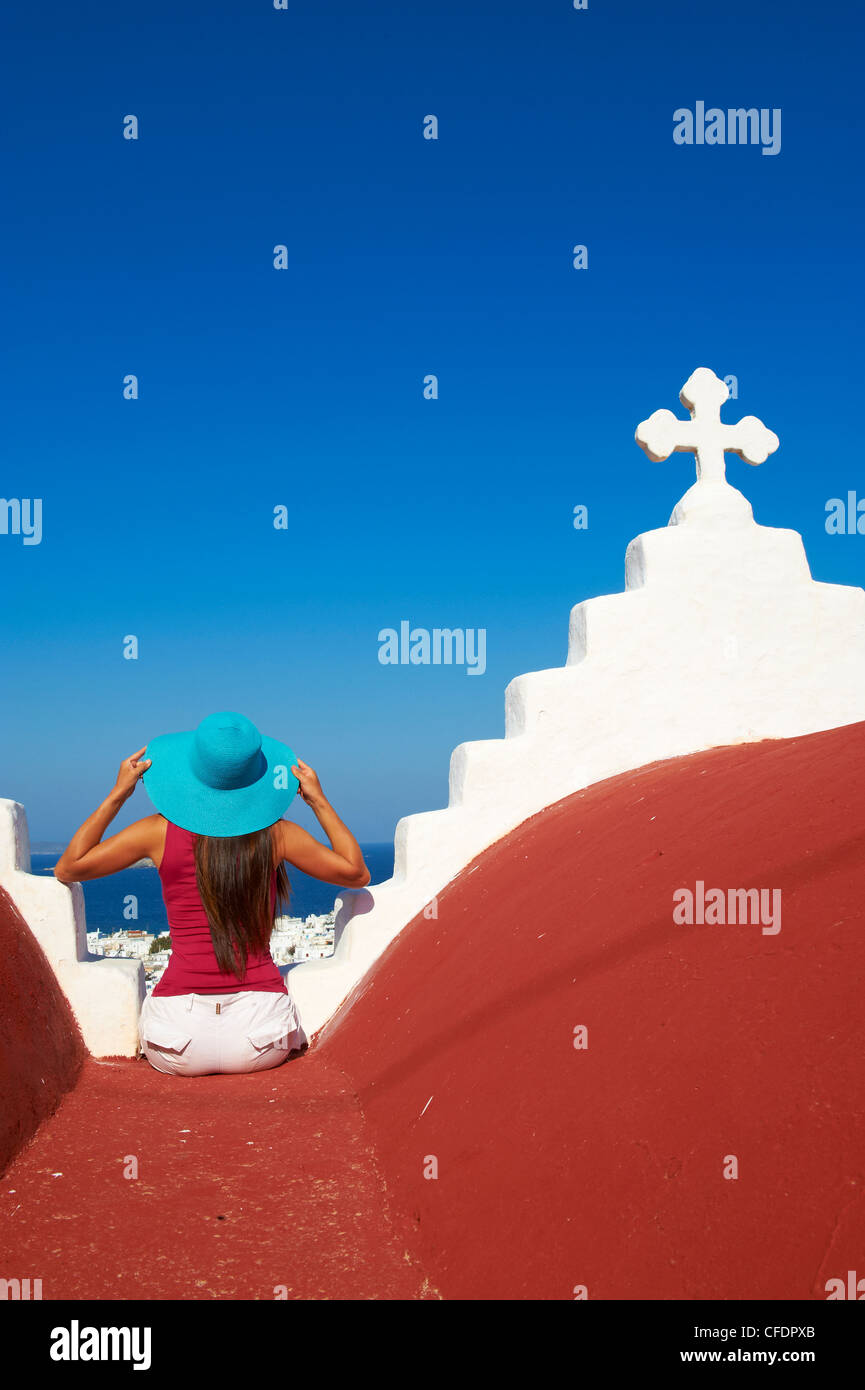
[{"left": 195, "top": 826, "right": 291, "bottom": 983}]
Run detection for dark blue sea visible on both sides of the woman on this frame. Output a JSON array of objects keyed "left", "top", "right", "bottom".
[{"left": 31, "top": 842, "right": 394, "bottom": 935}]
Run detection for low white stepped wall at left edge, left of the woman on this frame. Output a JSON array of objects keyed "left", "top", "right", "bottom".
[{"left": 0, "top": 799, "right": 145, "bottom": 1056}]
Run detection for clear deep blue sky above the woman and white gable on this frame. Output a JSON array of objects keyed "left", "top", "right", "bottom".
[{"left": 0, "top": 0, "right": 865, "bottom": 840}]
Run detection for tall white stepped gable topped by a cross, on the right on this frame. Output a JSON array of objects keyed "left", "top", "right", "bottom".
[{"left": 291, "top": 367, "right": 865, "bottom": 1034}]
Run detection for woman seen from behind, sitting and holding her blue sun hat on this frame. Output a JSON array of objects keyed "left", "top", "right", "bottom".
[{"left": 54, "top": 712, "right": 370, "bottom": 1076}]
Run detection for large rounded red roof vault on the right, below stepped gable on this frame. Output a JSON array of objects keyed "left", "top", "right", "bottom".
[{"left": 315, "top": 724, "right": 865, "bottom": 1300}]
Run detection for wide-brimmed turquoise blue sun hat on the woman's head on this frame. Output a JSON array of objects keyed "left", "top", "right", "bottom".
[{"left": 142, "top": 710, "right": 300, "bottom": 838}]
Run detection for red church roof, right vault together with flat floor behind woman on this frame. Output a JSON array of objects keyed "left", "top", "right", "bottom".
[{"left": 0, "top": 724, "right": 865, "bottom": 1300}]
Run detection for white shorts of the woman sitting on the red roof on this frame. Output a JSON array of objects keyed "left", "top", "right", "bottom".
[{"left": 138, "top": 990, "right": 307, "bottom": 1076}]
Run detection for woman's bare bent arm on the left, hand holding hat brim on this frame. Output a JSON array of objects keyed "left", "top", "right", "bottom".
[{"left": 54, "top": 745, "right": 164, "bottom": 883}]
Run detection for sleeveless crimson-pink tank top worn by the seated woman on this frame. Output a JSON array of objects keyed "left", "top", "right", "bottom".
[{"left": 153, "top": 821, "right": 288, "bottom": 995}]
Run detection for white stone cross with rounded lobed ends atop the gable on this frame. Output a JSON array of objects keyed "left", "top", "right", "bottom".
[{"left": 634, "top": 367, "right": 780, "bottom": 484}]
